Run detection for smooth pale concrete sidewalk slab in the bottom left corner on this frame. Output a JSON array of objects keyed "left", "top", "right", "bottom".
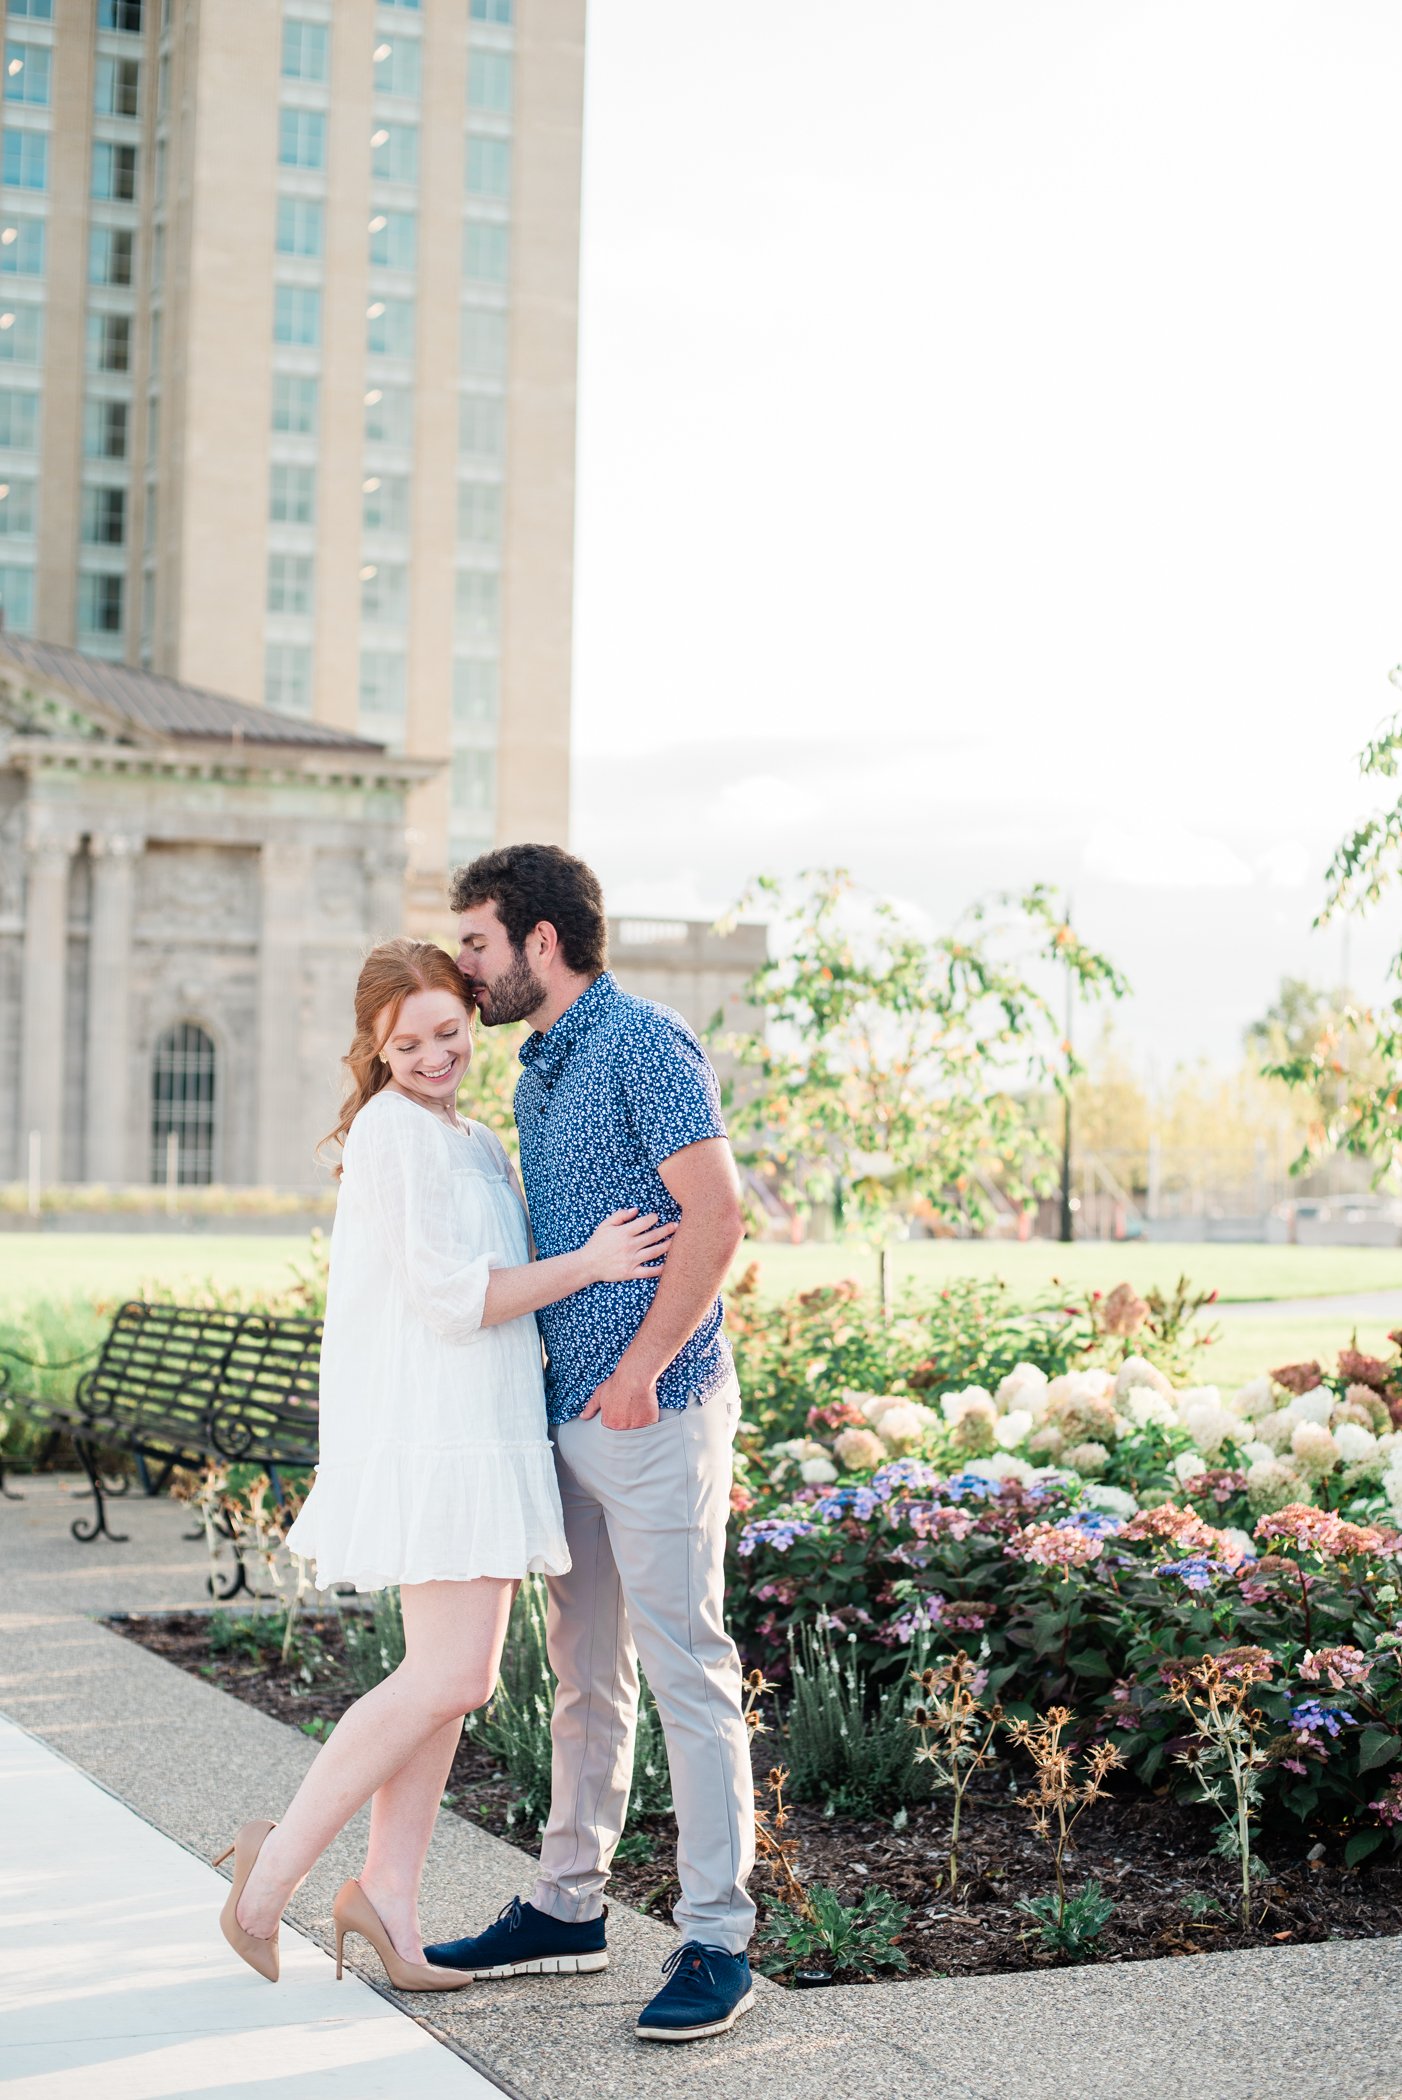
[{"left": 0, "top": 1720, "right": 500, "bottom": 2100}]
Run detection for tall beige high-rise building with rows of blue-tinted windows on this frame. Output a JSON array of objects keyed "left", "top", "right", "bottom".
[{"left": 0, "top": 0, "right": 583, "bottom": 930}]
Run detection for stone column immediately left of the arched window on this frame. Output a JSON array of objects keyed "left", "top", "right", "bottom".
[{"left": 84, "top": 834, "right": 147, "bottom": 1184}]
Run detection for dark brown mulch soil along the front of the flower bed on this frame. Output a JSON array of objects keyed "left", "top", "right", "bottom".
[{"left": 111, "top": 1613, "right": 1402, "bottom": 1980}]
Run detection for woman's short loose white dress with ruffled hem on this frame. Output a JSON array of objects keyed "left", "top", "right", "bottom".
[{"left": 288, "top": 1088, "right": 569, "bottom": 1590}]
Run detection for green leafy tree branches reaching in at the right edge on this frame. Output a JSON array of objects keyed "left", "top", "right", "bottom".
[{"left": 1263, "top": 692, "right": 1402, "bottom": 1182}]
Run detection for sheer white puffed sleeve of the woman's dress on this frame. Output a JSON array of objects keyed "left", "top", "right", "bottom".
[{"left": 344, "top": 1100, "right": 506, "bottom": 1342}]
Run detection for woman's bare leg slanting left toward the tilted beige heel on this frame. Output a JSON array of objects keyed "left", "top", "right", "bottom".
[{"left": 239, "top": 1579, "right": 516, "bottom": 1938}]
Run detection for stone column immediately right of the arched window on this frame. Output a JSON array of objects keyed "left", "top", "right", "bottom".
[{"left": 259, "top": 840, "right": 315, "bottom": 1189}]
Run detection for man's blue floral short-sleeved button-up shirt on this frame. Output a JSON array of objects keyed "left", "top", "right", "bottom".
[{"left": 516, "top": 970, "right": 730, "bottom": 1422}]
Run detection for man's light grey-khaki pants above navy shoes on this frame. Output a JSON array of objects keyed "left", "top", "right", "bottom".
[{"left": 531, "top": 1384, "right": 756, "bottom": 1953}]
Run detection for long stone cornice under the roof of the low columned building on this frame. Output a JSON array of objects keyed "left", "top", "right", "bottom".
[{"left": 0, "top": 735, "right": 447, "bottom": 788}]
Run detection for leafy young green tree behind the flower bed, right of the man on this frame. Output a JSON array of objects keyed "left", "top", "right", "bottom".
[{"left": 724, "top": 869, "right": 1127, "bottom": 1237}]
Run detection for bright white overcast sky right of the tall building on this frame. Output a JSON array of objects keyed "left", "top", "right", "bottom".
[{"left": 575, "top": 0, "right": 1402, "bottom": 1063}]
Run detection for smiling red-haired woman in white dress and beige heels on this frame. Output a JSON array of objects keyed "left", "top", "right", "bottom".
[{"left": 216, "top": 941, "right": 674, "bottom": 1991}]
